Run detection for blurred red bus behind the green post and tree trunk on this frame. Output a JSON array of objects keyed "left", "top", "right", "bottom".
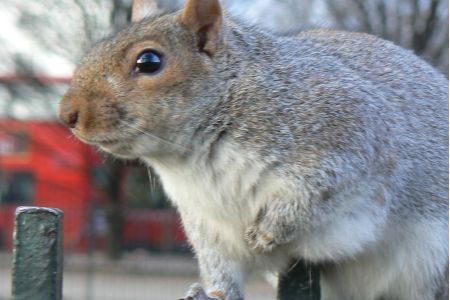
[{"left": 0, "top": 120, "right": 185, "bottom": 251}]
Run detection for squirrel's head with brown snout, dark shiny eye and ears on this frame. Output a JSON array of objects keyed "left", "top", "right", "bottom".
[{"left": 59, "top": 0, "right": 222, "bottom": 158}]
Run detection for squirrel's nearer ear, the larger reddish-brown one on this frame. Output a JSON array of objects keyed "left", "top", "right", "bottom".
[{"left": 181, "top": 0, "right": 222, "bottom": 56}]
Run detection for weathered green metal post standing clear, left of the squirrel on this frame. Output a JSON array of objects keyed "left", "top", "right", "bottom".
[{"left": 12, "top": 207, "right": 63, "bottom": 300}]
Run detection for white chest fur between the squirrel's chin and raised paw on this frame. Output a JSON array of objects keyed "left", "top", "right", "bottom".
[{"left": 147, "top": 144, "right": 281, "bottom": 257}]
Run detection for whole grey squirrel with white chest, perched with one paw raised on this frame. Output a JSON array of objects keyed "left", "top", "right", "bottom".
[{"left": 59, "top": 0, "right": 448, "bottom": 300}]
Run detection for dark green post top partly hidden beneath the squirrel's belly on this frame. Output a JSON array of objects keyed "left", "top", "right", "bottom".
[{"left": 277, "top": 260, "right": 320, "bottom": 300}]
